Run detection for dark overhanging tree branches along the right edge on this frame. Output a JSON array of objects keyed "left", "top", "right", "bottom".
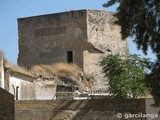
[{"left": 103, "top": 0, "right": 160, "bottom": 105}]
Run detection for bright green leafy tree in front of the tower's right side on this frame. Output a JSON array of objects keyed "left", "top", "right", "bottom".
[{"left": 100, "top": 55, "right": 149, "bottom": 99}]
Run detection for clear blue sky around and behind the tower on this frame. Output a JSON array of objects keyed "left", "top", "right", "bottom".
[{"left": 0, "top": 0, "right": 155, "bottom": 64}]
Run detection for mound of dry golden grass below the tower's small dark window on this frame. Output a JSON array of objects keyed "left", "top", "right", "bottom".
[{"left": 30, "top": 62, "right": 91, "bottom": 88}]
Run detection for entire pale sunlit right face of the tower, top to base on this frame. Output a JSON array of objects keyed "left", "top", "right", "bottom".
[{"left": 83, "top": 10, "right": 129, "bottom": 88}]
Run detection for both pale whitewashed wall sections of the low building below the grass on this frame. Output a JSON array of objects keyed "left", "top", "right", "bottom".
[{"left": 9, "top": 75, "right": 56, "bottom": 100}]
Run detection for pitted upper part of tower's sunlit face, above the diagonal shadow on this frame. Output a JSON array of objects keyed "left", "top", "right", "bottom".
[{"left": 87, "top": 10, "right": 129, "bottom": 56}]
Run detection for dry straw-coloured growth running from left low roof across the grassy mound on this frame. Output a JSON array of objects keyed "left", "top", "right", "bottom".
[{"left": 4, "top": 59, "right": 92, "bottom": 88}]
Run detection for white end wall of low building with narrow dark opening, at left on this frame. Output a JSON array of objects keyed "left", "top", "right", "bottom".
[{"left": 8, "top": 73, "right": 35, "bottom": 100}]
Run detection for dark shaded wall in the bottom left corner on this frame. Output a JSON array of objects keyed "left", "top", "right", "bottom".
[{"left": 0, "top": 88, "right": 15, "bottom": 120}]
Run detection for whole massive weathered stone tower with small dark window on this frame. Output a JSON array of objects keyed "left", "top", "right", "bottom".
[{"left": 18, "top": 10, "right": 128, "bottom": 87}]
